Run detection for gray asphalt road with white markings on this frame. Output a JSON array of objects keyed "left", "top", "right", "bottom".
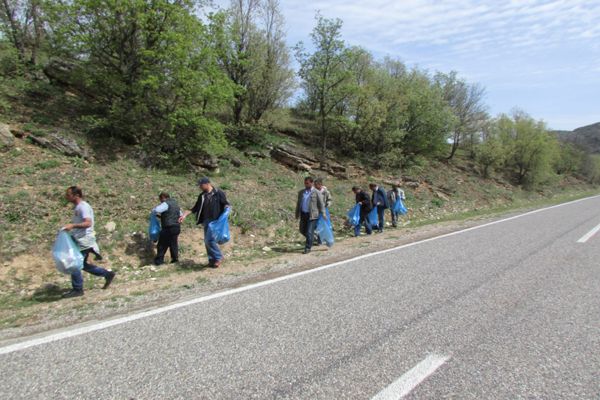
[{"left": 0, "top": 197, "right": 600, "bottom": 399}]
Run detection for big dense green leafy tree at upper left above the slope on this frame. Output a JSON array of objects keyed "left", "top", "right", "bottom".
[{"left": 49, "top": 0, "right": 233, "bottom": 161}]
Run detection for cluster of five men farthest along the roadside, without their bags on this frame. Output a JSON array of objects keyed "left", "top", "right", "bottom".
[{"left": 296, "top": 176, "right": 405, "bottom": 254}]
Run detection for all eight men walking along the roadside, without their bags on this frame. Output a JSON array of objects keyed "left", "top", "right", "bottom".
[{"left": 62, "top": 177, "right": 404, "bottom": 298}]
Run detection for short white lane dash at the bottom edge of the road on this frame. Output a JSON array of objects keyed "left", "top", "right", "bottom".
[{"left": 371, "top": 354, "right": 450, "bottom": 400}]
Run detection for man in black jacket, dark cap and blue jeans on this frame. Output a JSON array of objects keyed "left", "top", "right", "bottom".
[{"left": 179, "top": 177, "right": 230, "bottom": 268}]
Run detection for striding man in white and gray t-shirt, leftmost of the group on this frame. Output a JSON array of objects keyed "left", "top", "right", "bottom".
[{"left": 63, "top": 186, "right": 115, "bottom": 298}]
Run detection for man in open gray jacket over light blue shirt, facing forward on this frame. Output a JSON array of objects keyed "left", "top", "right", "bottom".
[{"left": 296, "top": 176, "right": 327, "bottom": 254}]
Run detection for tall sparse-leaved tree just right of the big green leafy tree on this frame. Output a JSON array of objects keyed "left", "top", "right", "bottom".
[{"left": 212, "top": 0, "right": 294, "bottom": 124}]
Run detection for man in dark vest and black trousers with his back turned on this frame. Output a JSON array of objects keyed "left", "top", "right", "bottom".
[{"left": 152, "top": 192, "right": 182, "bottom": 265}]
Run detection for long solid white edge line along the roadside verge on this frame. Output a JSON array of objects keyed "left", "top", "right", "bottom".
[{"left": 0, "top": 195, "right": 600, "bottom": 355}]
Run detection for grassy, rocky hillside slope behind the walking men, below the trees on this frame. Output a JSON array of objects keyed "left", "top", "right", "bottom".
[{"left": 0, "top": 115, "right": 592, "bottom": 327}]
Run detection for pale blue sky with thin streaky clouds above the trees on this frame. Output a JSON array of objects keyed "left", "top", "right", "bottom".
[{"left": 212, "top": 0, "right": 600, "bottom": 130}]
